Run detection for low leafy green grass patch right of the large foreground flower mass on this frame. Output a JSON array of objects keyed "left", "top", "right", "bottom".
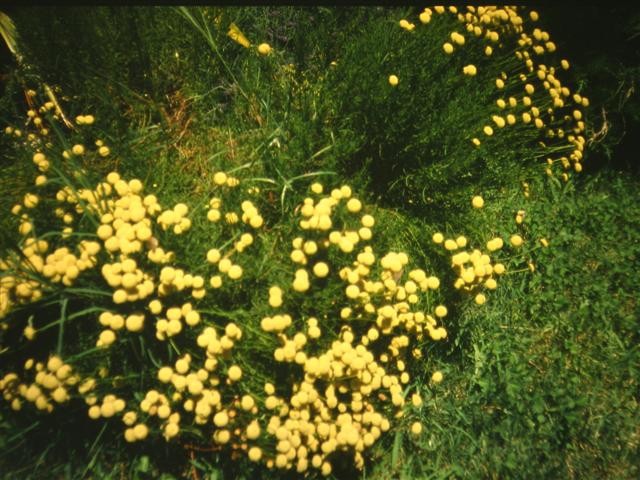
[{"left": 374, "top": 172, "right": 640, "bottom": 478}]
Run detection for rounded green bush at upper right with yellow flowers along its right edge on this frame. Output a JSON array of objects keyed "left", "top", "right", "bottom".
[{"left": 329, "top": 6, "right": 589, "bottom": 213}]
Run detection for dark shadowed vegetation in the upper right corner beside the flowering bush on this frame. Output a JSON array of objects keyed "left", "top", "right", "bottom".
[{"left": 539, "top": 2, "right": 640, "bottom": 174}]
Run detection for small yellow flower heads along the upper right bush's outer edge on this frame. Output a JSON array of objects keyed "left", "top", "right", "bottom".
[{"left": 396, "top": 6, "right": 589, "bottom": 181}]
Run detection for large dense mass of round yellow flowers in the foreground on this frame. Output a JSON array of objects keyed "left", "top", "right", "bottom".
[{"left": 1, "top": 152, "right": 447, "bottom": 474}]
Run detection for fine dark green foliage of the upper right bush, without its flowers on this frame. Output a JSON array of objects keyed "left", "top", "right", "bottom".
[{"left": 327, "top": 10, "right": 584, "bottom": 222}]
